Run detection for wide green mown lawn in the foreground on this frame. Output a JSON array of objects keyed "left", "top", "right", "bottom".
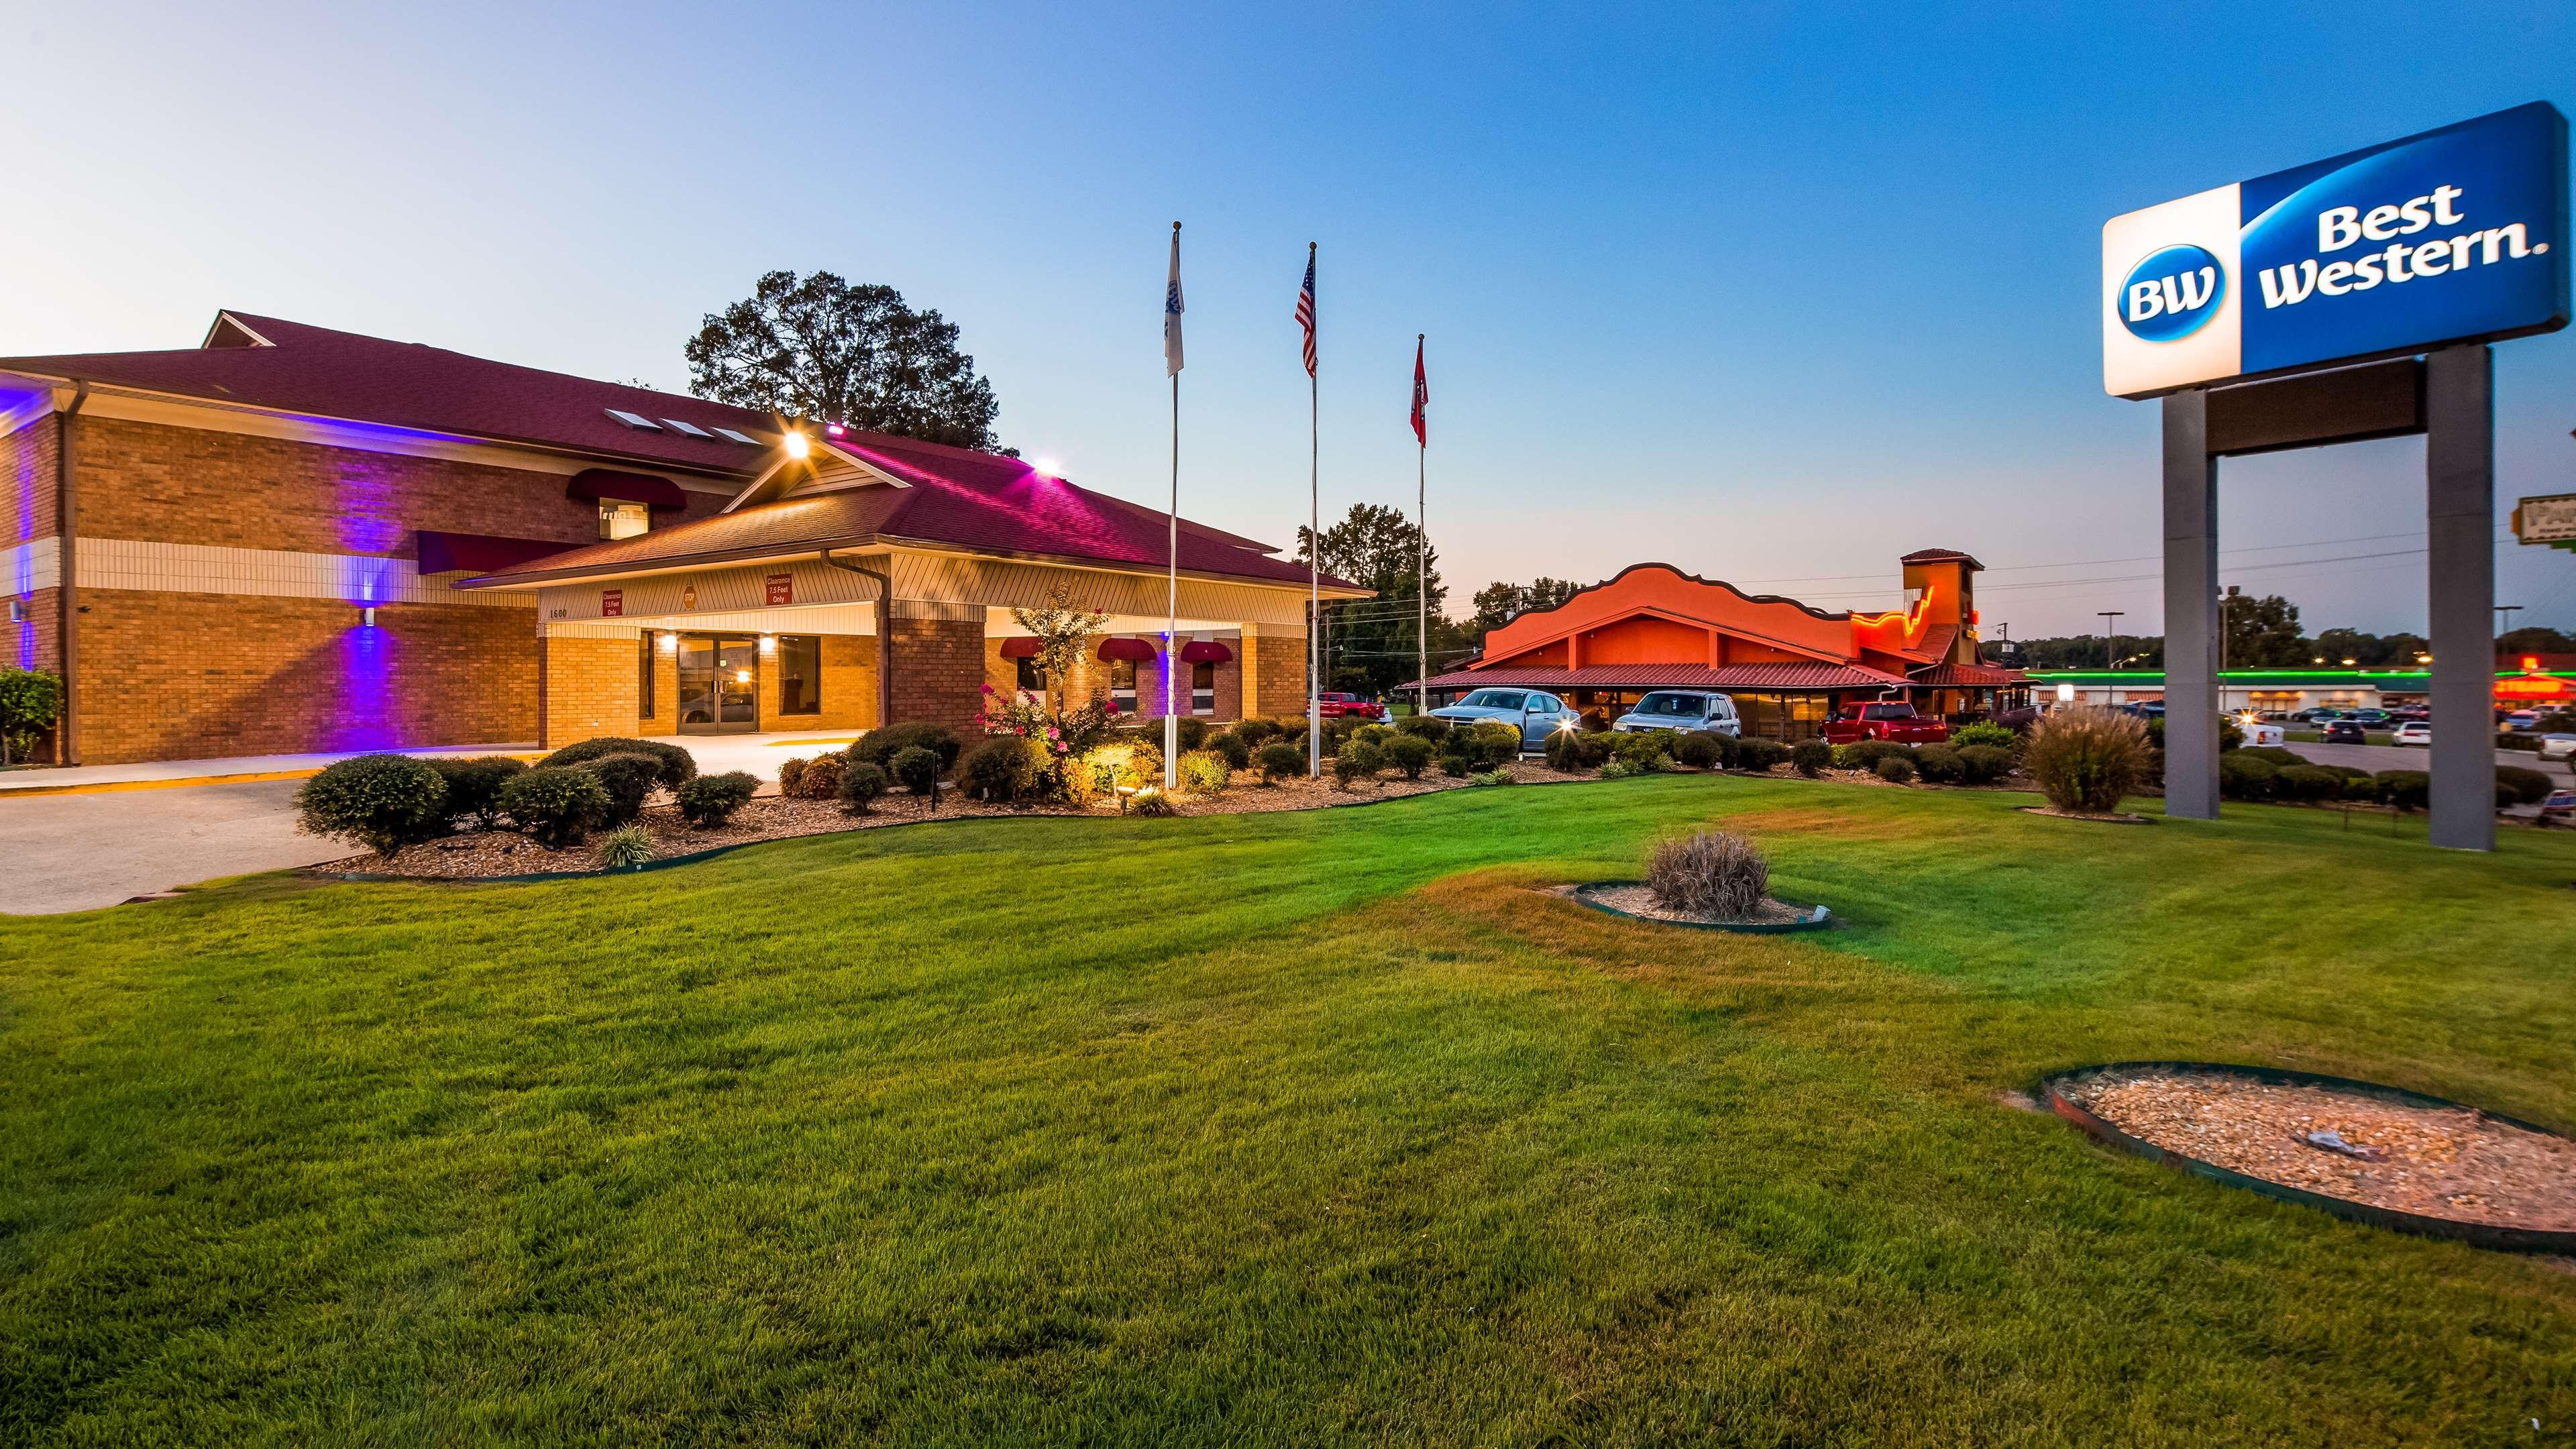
[{"left": 0, "top": 776, "right": 2576, "bottom": 1449}]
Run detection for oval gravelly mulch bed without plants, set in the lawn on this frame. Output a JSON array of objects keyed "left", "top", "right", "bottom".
[{"left": 2066, "top": 1073, "right": 2576, "bottom": 1232}]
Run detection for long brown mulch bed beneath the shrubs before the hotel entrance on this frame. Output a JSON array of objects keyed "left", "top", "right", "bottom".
[{"left": 314, "top": 761, "right": 1587, "bottom": 879}]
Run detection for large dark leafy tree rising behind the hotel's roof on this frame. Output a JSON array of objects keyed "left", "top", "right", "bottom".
[{"left": 688, "top": 271, "right": 1002, "bottom": 451}]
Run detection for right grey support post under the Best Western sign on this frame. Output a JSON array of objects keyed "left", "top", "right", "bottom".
[{"left": 2424, "top": 343, "right": 2496, "bottom": 851}]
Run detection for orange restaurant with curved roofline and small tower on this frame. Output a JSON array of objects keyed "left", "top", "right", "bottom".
[{"left": 1430, "top": 549, "right": 2030, "bottom": 740}]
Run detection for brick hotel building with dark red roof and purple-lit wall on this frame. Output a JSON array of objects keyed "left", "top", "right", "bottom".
[{"left": 0, "top": 312, "right": 1365, "bottom": 763}]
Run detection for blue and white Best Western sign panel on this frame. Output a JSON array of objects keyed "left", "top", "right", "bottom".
[{"left": 2102, "top": 101, "right": 2571, "bottom": 397}]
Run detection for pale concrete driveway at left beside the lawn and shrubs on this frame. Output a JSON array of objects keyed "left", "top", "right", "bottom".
[{"left": 0, "top": 779, "right": 353, "bottom": 915}]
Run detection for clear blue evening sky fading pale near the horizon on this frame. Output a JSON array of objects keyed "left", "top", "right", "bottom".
[{"left": 0, "top": 0, "right": 2576, "bottom": 637}]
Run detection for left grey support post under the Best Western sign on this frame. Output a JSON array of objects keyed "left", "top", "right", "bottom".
[{"left": 2164, "top": 387, "right": 2218, "bottom": 820}]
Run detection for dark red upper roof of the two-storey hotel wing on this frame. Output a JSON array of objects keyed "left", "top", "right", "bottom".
[{"left": 0, "top": 312, "right": 778, "bottom": 474}]
